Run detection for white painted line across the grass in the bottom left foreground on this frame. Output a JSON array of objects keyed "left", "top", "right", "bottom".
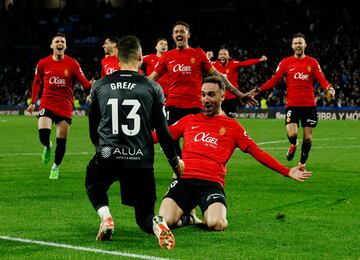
[{"left": 0, "top": 236, "right": 173, "bottom": 260}]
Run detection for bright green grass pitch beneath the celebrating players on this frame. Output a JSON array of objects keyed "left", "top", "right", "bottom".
[{"left": 0, "top": 116, "right": 360, "bottom": 259}]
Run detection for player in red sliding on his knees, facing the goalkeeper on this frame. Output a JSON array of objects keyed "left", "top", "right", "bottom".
[{"left": 153, "top": 76, "right": 312, "bottom": 248}]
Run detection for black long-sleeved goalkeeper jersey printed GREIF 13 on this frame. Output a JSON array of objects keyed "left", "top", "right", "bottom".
[{"left": 89, "top": 70, "right": 176, "bottom": 168}]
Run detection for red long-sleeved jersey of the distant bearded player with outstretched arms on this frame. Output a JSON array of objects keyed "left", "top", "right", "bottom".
[{"left": 211, "top": 59, "right": 260, "bottom": 99}]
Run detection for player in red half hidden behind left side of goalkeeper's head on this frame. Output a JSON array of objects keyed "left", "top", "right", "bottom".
[{"left": 101, "top": 36, "right": 120, "bottom": 78}]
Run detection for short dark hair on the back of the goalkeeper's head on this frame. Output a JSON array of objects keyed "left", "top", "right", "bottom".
[{"left": 118, "top": 35, "right": 141, "bottom": 62}]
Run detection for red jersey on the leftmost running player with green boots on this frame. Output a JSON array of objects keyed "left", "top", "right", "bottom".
[{"left": 31, "top": 55, "right": 91, "bottom": 118}]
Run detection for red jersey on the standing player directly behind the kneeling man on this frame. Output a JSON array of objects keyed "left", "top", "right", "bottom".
[{"left": 155, "top": 47, "right": 215, "bottom": 109}]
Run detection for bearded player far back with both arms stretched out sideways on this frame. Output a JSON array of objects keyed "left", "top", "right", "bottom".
[{"left": 207, "top": 48, "right": 267, "bottom": 117}]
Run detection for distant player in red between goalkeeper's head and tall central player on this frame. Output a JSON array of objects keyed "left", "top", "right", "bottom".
[{"left": 142, "top": 38, "right": 169, "bottom": 98}]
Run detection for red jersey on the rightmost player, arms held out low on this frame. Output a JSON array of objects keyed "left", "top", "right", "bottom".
[{"left": 260, "top": 56, "right": 329, "bottom": 107}]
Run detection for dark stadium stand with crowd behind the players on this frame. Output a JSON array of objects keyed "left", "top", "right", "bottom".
[{"left": 0, "top": 0, "right": 360, "bottom": 108}]
